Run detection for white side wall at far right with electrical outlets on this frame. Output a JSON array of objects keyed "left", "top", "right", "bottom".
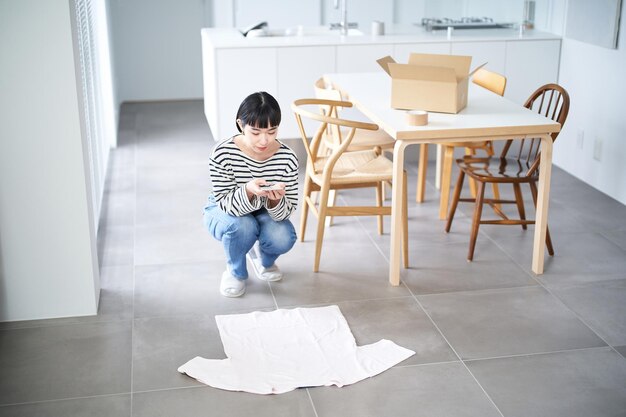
[{"left": 554, "top": 2, "right": 626, "bottom": 204}]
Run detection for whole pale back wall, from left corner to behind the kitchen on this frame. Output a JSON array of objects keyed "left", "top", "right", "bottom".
[{"left": 112, "top": 0, "right": 544, "bottom": 107}]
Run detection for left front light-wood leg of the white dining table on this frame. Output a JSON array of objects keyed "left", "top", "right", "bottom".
[{"left": 389, "top": 140, "right": 408, "bottom": 287}]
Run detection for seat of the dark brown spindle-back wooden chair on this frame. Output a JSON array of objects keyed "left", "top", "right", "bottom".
[{"left": 456, "top": 156, "right": 538, "bottom": 182}]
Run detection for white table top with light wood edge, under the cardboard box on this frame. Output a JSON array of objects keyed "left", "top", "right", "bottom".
[{"left": 324, "top": 70, "right": 561, "bottom": 143}]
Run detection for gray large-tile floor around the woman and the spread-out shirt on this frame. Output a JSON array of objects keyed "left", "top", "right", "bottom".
[{"left": 0, "top": 101, "right": 626, "bottom": 417}]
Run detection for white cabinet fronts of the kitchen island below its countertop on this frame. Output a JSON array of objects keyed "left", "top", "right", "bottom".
[{"left": 202, "top": 31, "right": 561, "bottom": 140}]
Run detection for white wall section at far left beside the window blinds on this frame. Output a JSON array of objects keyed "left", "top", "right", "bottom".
[{"left": 0, "top": 0, "right": 99, "bottom": 321}]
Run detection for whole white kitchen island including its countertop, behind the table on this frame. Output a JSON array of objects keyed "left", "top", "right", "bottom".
[{"left": 202, "top": 25, "right": 561, "bottom": 140}]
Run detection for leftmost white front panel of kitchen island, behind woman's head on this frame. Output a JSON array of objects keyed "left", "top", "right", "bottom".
[{"left": 211, "top": 48, "right": 278, "bottom": 141}]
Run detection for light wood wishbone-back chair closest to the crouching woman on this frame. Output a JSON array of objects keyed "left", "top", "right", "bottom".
[{"left": 291, "top": 99, "right": 408, "bottom": 272}]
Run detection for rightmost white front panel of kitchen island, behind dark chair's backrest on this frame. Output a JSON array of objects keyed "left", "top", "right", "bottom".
[{"left": 504, "top": 39, "right": 561, "bottom": 104}]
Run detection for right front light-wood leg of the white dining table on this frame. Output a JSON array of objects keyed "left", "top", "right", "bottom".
[{"left": 532, "top": 134, "right": 552, "bottom": 275}]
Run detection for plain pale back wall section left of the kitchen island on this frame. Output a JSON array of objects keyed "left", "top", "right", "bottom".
[{"left": 109, "top": 0, "right": 208, "bottom": 104}]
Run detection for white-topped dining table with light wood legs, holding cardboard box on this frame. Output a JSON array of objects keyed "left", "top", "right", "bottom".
[{"left": 324, "top": 70, "right": 561, "bottom": 286}]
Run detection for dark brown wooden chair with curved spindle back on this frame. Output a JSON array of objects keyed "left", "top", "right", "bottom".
[{"left": 446, "top": 84, "right": 570, "bottom": 261}]
